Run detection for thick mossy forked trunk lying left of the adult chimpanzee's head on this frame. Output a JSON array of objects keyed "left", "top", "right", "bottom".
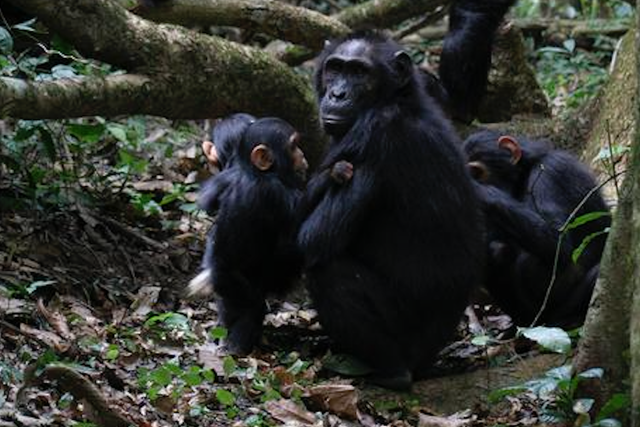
[{"left": 0, "top": 0, "right": 323, "bottom": 166}]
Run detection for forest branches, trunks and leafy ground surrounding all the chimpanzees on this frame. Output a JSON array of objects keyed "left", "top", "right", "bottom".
[{"left": 0, "top": 0, "right": 640, "bottom": 427}]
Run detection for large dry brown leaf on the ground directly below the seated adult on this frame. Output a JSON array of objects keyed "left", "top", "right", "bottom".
[{"left": 305, "top": 384, "right": 358, "bottom": 420}]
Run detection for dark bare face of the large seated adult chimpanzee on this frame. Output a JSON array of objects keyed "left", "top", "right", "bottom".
[{"left": 320, "top": 39, "right": 380, "bottom": 136}]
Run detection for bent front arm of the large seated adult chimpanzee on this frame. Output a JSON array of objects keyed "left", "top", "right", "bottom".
[{"left": 298, "top": 168, "right": 376, "bottom": 264}]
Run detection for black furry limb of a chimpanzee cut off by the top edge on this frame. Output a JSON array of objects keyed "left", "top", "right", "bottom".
[{"left": 426, "top": 0, "right": 516, "bottom": 122}]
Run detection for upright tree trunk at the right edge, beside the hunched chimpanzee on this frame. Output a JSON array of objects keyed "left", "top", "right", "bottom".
[{"left": 574, "top": 7, "right": 640, "bottom": 427}]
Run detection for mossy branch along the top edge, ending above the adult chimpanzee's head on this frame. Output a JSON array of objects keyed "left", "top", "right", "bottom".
[{"left": 136, "top": 0, "right": 350, "bottom": 50}]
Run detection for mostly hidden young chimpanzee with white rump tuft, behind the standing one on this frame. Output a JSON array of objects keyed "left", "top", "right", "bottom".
[{"left": 186, "top": 113, "right": 256, "bottom": 298}]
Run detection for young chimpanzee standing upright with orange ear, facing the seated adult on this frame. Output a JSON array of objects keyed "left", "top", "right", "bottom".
[{"left": 199, "top": 118, "right": 307, "bottom": 354}]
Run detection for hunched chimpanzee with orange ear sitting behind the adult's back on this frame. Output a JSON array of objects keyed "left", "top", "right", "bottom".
[{"left": 464, "top": 131, "right": 610, "bottom": 327}]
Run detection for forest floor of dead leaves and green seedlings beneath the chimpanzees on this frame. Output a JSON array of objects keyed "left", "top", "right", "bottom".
[{"left": 0, "top": 195, "right": 580, "bottom": 427}]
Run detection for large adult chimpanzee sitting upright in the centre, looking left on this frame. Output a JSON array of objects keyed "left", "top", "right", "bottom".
[{"left": 298, "top": 33, "right": 483, "bottom": 389}]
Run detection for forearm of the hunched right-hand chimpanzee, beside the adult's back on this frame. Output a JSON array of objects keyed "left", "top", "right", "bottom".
[{"left": 477, "top": 184, "right": 571, "bottom": 264}]
